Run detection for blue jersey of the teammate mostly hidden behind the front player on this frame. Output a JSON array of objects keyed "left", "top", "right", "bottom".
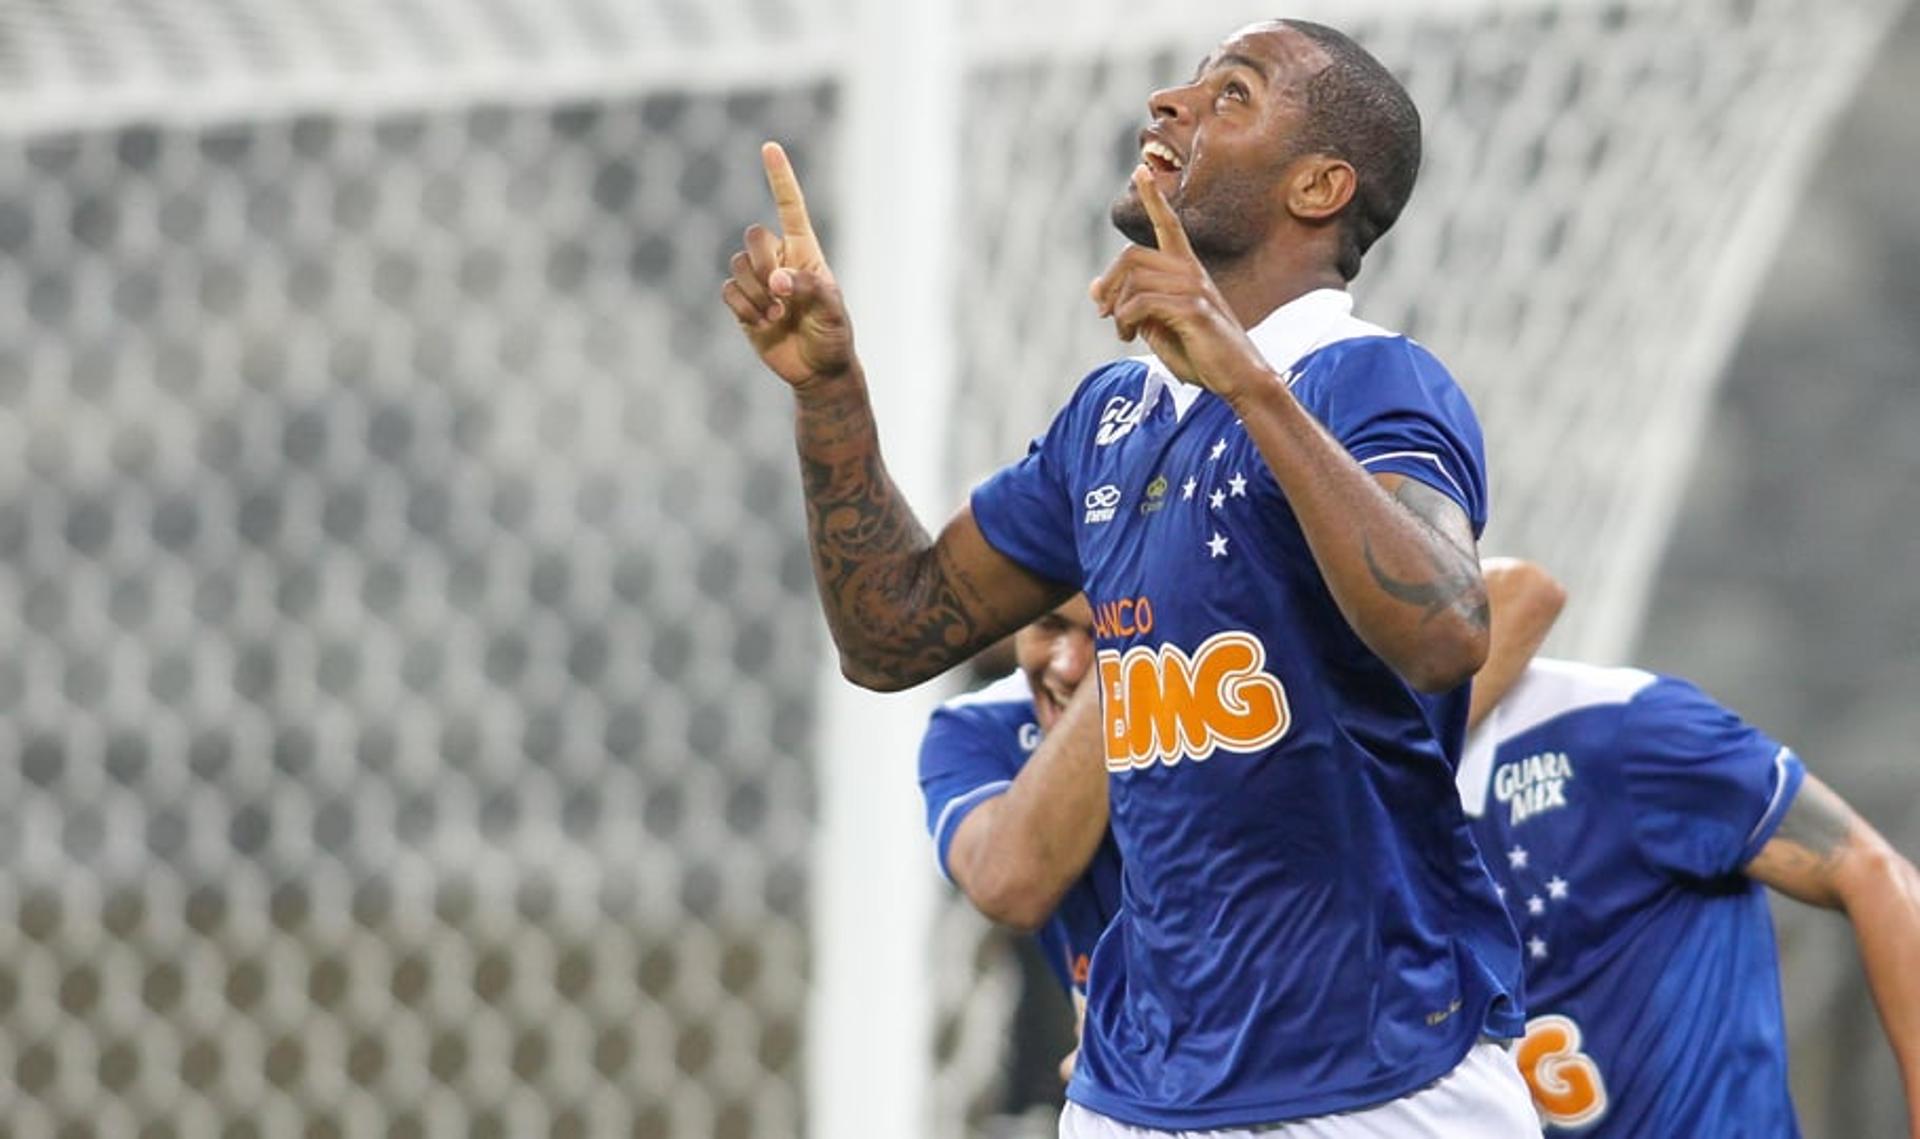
[{"left": 920, "top": 672, "right": 1119, "bottom": 995}]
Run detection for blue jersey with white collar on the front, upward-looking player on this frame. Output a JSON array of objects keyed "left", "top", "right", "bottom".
[{"left": 973, "top": 290, "right": 1523, "bottom": 1129}]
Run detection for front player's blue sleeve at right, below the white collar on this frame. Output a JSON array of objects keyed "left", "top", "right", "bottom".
[{"left": 1302, "top": 336, "right": 1486, "bottom": 534}]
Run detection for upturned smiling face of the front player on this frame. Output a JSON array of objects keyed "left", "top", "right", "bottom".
[{"left": 1114, "top": 23, "right": 1327, "bottom": 265}]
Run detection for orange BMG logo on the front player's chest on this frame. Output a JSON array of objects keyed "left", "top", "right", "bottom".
[{"left": 1098, "top": 632, "right": 1292, "bottom": 770}]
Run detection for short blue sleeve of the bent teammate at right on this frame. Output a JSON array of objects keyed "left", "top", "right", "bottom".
[{"left": 1619, "top": 678, "right": 1807, "bottom": 880}]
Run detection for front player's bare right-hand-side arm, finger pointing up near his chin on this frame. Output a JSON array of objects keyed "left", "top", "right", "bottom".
[{"left": 1092, "top": 167, "right": 1488, "bottom": 691}]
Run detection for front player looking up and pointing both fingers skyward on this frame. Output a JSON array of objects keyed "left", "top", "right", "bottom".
[{"left": 722, "top": 13, "right": 1538, "bottom": 1139}]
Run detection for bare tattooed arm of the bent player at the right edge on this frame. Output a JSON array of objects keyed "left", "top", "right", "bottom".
[{"left": 1747, "top": 776, "right": 1920, "bottom": 1139}]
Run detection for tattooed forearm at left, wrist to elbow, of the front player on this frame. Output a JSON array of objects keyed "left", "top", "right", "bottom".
[{"left": 795, "top": 378, "right": 995, "bottom": 688}]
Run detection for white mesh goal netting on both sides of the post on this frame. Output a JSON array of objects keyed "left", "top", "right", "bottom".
[{"left": 0, "top": 0, "right": 1887, "bottom": 1139}]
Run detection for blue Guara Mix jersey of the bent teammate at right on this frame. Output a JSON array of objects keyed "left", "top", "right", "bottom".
[{"left": 1459, "top": 661, "right": 1805, "bottom": 1139}]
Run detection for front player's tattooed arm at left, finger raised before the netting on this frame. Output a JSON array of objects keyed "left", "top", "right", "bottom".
[{"left": 720, "top": 142, "right": 1069, "bottom": 690}]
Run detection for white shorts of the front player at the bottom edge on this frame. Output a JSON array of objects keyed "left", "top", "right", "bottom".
[{"left": 1060, "top": 1041, "right": 1540, "bottom": 1139}]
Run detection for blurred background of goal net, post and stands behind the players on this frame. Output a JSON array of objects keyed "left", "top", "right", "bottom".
[{"left": 0, "top": 0, "right": 1920, "bottom": 1139}]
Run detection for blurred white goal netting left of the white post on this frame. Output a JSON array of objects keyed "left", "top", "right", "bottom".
[{"left": 0, "top": 4, "right": 848, "bottom": 1139}]
